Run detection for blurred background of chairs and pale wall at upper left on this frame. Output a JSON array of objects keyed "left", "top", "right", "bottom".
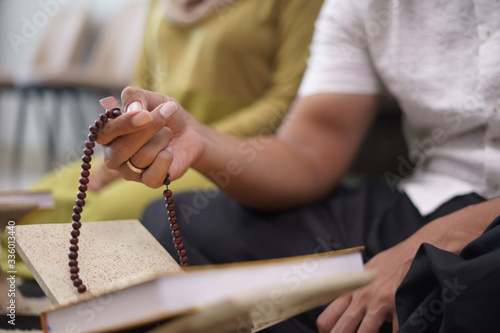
[{"left": 0, "top": 0, "right": 147, "bottom": 191}]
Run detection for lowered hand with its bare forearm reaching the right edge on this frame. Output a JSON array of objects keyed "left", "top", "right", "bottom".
[{"left": 317, "top": 198, "right": 500, "bottom": 333}]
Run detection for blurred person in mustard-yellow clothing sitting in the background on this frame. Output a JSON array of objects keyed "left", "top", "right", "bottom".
[{"left": 19, "top": 0, "right": 322, "bottom": 224}]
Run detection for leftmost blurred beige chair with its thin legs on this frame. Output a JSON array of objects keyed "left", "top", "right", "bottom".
[{"left": 12, "top": 9, "right": 91, "bottom": 175}]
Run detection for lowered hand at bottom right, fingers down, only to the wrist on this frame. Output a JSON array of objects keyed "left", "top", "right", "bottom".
[{"left": 317, "top": 242, "right": 416, "bottom": 333}]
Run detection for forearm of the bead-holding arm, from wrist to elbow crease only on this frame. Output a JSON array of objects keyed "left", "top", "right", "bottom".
[{"left": 194, "top": 128, "right": 342, "bottom": 209}]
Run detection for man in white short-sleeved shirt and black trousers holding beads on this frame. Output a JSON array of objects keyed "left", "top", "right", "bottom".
[{"left": 98, "top": 0, "right": 500, "bottom": 332}]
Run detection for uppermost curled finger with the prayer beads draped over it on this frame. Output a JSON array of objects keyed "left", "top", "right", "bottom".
[{"left": 96, "top": 111, "right": 153, "bottom": 145}]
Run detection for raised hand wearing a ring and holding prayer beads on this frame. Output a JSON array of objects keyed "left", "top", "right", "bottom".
[{"left": 97, "top": 87, "right": 202, "bottom": 188}]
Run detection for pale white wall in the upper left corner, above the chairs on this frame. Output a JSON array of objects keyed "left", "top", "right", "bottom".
[{"left": 0, "top": 0, "right": 141, "bottom": 71}]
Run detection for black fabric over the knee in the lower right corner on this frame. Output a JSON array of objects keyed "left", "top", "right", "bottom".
[{"left": 396, "top": 217, "right": 500, "bottom": 333}]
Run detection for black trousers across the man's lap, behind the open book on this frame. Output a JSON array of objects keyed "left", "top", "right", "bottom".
[{"left": 142, "top": 179, "right": 484, "bottom": 333}]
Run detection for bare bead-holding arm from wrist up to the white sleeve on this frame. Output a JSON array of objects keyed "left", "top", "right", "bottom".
[{"left": 189, "top": 95, "right": 376, "bottom": 209}]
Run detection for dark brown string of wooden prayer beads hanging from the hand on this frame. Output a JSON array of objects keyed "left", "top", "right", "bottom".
[{"left": 68, "top": 108, "right": 188, "bottom": 293}]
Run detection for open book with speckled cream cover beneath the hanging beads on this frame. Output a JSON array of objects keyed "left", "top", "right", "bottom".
[{"left": 16, "top": 220, "right": 373, "bottom": 333}]
